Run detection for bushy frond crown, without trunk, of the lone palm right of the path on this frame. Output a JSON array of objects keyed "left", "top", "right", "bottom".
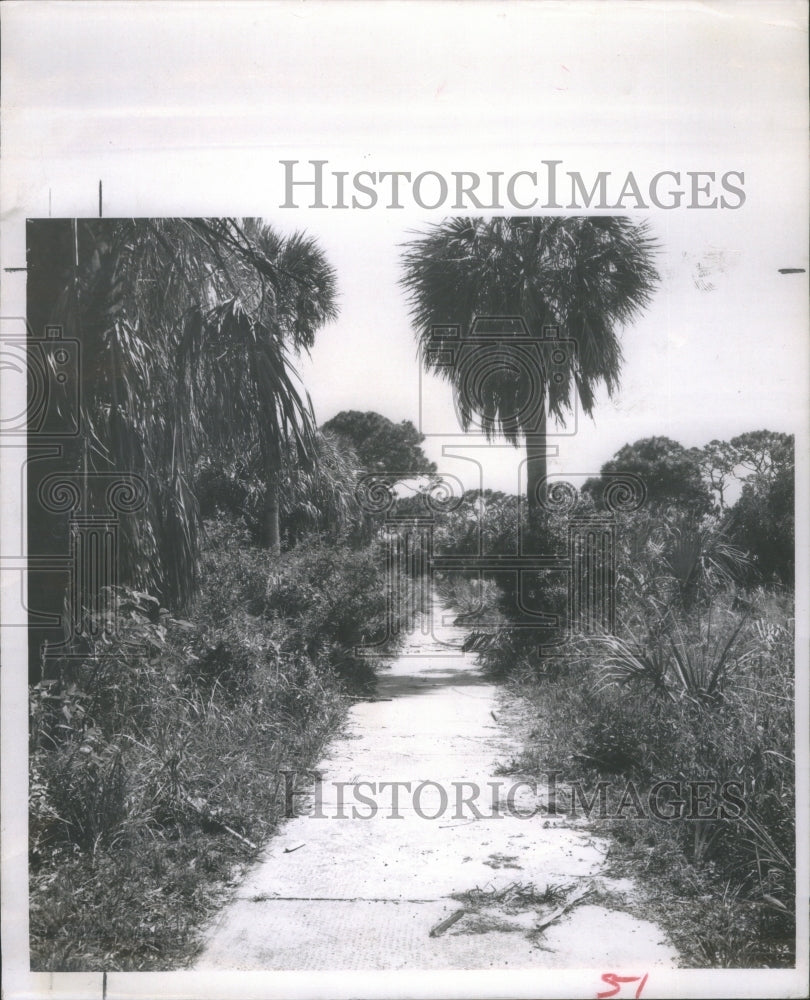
[{"left": 403, "top": 217, "right": 657, "bottom": 430}]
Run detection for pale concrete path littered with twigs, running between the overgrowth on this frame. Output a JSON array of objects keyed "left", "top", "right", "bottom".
[{"left": 196, "top": 608, "right": 677, "bottom": 970}]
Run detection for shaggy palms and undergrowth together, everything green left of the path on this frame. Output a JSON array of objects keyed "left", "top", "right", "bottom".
[{"left": 28, "top": 219, "right": 427, "bottom": 970}]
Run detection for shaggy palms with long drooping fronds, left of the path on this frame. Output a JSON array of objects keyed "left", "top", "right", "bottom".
[{"left": 28, "top": 219, "right": 335, "bottom": 606}]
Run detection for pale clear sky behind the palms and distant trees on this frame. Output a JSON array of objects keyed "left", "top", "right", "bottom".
[{"left": 301, "top": 195, "right": 807, "bottom": 490}]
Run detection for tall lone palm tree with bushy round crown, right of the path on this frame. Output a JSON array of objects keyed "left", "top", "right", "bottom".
[{"left": 402, "top": 216, "right": 658, "bottom": 509}]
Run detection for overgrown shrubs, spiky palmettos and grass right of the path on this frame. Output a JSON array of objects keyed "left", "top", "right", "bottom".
[{"left": 438, "top": 456, "right": 795, "bottom": 967}]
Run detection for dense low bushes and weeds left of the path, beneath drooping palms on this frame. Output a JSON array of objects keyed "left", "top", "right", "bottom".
[{"left": 30, "top": 518, "right": 404, "bottom": 971}]
